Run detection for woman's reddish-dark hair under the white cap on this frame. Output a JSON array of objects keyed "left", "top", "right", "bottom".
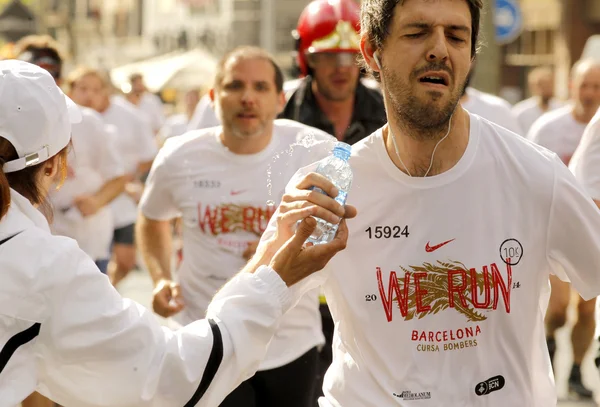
[{"left": 0, "top": 137, "right": 69, "bottom": 222}]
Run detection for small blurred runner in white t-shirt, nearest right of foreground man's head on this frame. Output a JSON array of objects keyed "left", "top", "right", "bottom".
[{"left": 512, "top": 66, "right": 563, "bottom": 135}]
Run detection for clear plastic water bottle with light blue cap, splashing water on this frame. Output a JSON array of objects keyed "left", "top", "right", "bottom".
[{"left": 307, "top": 142, "right": 352, "bottom": 244}]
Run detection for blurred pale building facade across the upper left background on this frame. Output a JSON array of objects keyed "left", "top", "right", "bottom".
[{"left": 0, "top": 0, "right": 309, "bottom": 76}]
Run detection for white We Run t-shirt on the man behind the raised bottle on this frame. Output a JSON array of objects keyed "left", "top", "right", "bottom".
[{"left": 140, "top": 120, "right": 335, "bottom": 370}]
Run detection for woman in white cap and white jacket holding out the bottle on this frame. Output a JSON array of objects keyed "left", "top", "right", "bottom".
[{"left": 0, "top": 61, "right": 356, "bottom": 407}]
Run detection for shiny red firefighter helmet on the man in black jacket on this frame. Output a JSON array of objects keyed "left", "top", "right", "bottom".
[{"left": 292, "top": 0, "right": 360, "bottom": 76}]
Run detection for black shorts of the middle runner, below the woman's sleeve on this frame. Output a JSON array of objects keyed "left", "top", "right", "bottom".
[{"left": 219, "top": 348, "right": 319, "bottom": 407}]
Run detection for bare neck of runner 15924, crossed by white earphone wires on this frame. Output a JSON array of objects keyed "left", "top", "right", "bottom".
[{"left": 384, "top": 105, "right": 470, "bottom": 177}]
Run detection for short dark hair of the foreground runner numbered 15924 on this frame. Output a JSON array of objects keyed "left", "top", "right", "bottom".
[{"left": 360, "top": 0, "right": 483, "bottom": 80}]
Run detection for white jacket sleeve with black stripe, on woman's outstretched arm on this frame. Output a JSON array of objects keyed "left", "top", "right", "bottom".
[{"left": 36, "top": 242, "right": 289, "bottom": 407}]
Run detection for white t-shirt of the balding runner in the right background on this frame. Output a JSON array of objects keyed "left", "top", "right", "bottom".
[{"left": 527, "top": 106, "right": 586, "bottom": 165}]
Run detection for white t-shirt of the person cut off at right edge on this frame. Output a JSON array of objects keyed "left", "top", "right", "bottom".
[{"left": 569, "top": 109, "right": 600, "bottom": 201}]
